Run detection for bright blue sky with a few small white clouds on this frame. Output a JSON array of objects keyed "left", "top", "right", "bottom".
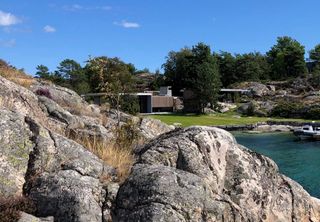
[{"left": 0, "top": 0, "right": 320, "bottom": 74}]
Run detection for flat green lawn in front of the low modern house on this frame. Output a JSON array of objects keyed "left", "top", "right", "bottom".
[{"left": 149, "top": 113, "right": 312, "bottom": 127}]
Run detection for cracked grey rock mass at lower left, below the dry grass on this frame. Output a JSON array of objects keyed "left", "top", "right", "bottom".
[{"left": 0, "top": 109, "right": 118, "bottom": 221}]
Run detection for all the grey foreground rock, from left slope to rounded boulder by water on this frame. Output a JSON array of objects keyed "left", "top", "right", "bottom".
[{"left": 0, "top": 77, "right": 320, "bottom": 222}]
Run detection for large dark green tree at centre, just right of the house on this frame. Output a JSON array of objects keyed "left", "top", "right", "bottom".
[{"left": 163, "top": 43, "right": 221, "bottom": 112}]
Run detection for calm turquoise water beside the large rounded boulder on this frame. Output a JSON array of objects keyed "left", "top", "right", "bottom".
[{"left": 234, "top": 133, "right": 320, "bottom": 198}]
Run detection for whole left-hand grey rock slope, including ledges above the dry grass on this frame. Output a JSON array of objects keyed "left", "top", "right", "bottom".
[{"left": 0, "top": 76, "right": 172, "bottom": 221}]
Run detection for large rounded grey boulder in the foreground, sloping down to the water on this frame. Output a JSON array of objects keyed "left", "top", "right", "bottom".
[{"left": 115, "top": 127, "right": 320, "bottom": 222}]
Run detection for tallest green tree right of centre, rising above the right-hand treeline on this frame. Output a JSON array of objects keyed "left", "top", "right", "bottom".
[{"left": 267, "top": 36, "right": 306, "bottom": 80}]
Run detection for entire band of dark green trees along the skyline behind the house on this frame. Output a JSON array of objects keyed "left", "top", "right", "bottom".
[{"left": 36, "top": 36, "right": 320, "bottom": 112}]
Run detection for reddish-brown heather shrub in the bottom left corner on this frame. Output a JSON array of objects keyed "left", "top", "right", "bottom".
[{"left": 0, "top": 196, "right": 35, "bottom": 222}]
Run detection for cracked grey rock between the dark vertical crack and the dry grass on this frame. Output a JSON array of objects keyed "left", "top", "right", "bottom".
[{"left": 24, "top": 118, "right": 117, "bottom": 221}]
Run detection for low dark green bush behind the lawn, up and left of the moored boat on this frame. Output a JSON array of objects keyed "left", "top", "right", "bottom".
[{"left": 271, "top": 102, "right": 303, "bottom": 118}]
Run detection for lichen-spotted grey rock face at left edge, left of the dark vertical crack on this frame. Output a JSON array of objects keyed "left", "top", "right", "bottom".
[{"left": 0, "top": 108, "right": 34, "bottom": 196}]
